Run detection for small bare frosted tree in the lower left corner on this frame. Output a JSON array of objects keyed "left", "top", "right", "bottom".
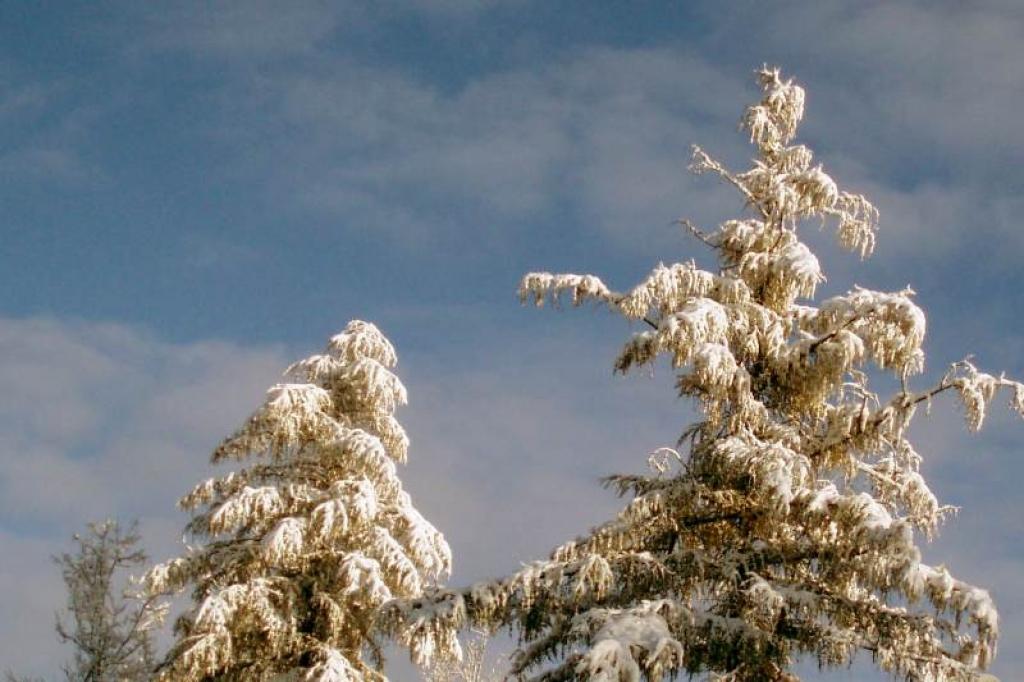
[{"left": 7, "top": 520, "right": 164, "bottom": 682}]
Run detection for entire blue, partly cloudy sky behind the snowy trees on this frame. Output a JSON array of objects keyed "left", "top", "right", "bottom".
[{"left": 0, "top": 0, "right": 1024, "bottom": 680}]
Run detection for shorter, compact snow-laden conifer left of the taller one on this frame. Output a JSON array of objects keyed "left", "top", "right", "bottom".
[{"left": 147, "top": 322, "right": 457, "bottom": 682}]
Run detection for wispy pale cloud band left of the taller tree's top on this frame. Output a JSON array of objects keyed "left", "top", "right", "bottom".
[{"left": 199, "top": 49, "right": 750, "bottom": 254}]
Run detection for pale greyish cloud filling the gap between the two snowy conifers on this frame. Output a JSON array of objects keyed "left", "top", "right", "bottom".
[{"left": 403, "top": 338, "right": 687, "bottom": 583}]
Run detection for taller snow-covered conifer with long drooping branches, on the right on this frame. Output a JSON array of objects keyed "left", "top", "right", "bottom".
[{"left": 386, "top": 68, "right": 1024, "bottom": 682}]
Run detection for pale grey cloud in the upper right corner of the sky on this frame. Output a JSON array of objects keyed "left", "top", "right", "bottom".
[{"left": 708, "top": 0, "right": 1024, "bottom": 176}]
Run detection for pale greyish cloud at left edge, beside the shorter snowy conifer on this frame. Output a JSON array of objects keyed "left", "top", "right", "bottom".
[{"left": 0, "top": 318, "right": 284, "bottom": 675}]
